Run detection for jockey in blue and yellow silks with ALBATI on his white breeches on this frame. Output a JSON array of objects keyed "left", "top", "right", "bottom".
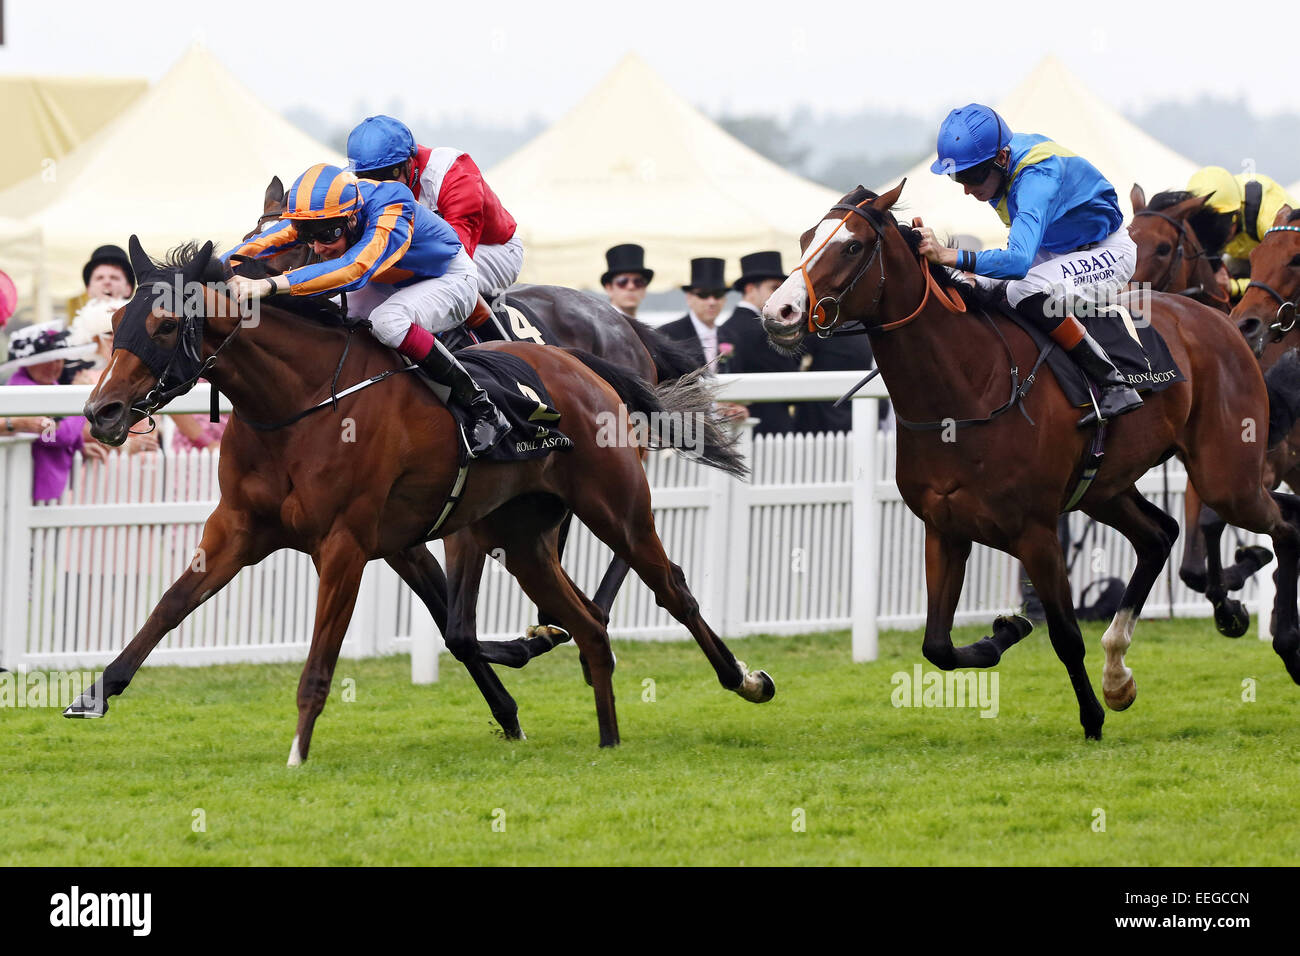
[{"left": 919, "top": 103, "right": 1141, "bottom": 423}]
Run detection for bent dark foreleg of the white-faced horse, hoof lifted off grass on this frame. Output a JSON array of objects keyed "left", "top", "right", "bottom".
[{"left": 920, "top": 524, "right": 1037, "bottom": 670}]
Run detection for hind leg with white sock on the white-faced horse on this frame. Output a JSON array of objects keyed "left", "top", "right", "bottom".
[{"left": 1084, "top": 486, "right": 1200, "bottom": 710}]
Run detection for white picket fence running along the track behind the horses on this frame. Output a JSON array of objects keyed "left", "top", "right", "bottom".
[{"left": 0, "top": 373, "right": 1255, "bottom": 679}]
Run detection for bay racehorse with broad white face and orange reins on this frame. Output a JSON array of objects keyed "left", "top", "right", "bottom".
[{"left": 763, "top": 183, "right": 1300, "bottom": 739}]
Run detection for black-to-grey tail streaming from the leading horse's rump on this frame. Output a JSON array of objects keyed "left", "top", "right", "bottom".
[{"left": 564, "top": 349, "right": 749, "bottom": 477}]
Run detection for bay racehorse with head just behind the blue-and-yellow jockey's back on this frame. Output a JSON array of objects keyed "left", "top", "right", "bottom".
[{"left": 1128, "top": 183, "right": 1268, "bottom": 637}]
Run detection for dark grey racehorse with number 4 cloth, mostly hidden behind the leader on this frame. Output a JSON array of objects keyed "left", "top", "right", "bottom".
[{"left": 235, "top": 176, "right": 712, "bottom": 723}]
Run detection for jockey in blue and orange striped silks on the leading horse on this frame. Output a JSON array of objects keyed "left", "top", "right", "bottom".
[{"left": 222, "top": 164, "right": 508, "bottom": 458}]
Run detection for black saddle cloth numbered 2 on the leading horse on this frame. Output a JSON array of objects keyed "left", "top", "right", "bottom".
[{"left": 450, "top": 349, "right": 573, "bottom": 462}]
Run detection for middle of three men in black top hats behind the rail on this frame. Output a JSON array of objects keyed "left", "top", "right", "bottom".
[{"left": 718, "top": 252, "right": 800, "bottom": 434}]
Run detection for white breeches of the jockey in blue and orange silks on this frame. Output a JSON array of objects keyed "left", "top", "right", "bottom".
[{"left": 347, "top": 250, "right": 478, "bottom": 349}]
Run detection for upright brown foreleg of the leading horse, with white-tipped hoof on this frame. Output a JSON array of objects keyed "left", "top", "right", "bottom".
[{"left": 289, "top": 531, "right": 365, "bottom": 767}]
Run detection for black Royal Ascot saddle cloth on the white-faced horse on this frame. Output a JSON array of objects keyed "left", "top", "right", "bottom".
[{"left": 1000, "top": 297, "right": 1187, "bottom": 407}]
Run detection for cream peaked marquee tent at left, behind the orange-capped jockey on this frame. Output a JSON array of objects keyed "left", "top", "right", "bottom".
[{"left": 0, "top": 44, "right": 346, "bottom": 312}]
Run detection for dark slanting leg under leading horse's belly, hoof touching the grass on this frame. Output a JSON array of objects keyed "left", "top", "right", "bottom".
[{"left": 387, "top": 535, "right": 524, "bottom": 740}]
